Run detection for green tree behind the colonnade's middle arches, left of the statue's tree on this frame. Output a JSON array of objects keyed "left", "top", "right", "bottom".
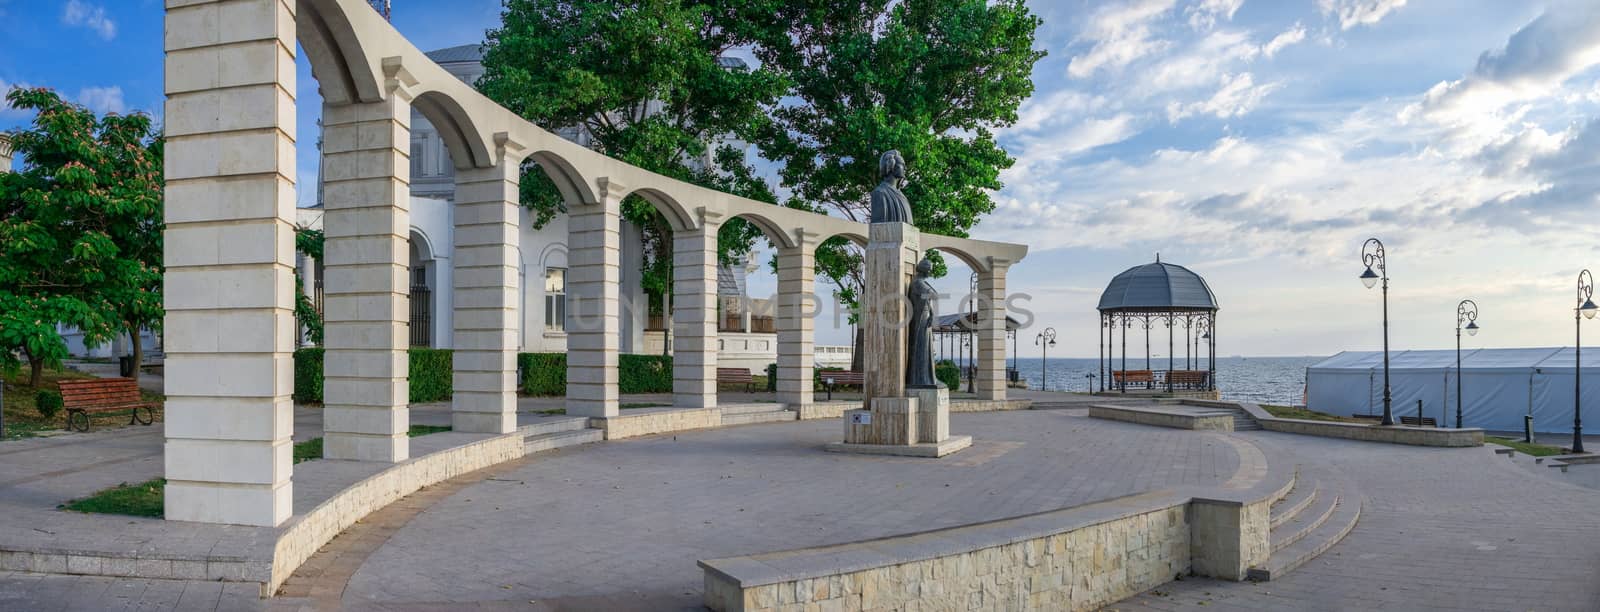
[{"left": 477, "top": 0, "right": 784, "bottom": 311}]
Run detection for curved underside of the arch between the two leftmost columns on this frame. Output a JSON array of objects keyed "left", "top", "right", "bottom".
[{"left": 294, "top": 0, "right": 382, "bottom": 104}]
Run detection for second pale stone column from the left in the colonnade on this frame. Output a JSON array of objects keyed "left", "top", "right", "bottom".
[{"left": 322, "top": 91, "right": 411, "bottom": 463}]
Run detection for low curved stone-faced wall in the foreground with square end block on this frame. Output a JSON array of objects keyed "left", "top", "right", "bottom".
[{"left": 699, "top": 487, "right": 1288, "bottom": 612}]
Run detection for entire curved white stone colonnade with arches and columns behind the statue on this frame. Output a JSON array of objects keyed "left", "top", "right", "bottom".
[{"left": 165, "top": 0, "right": 1027, "bottom": 525}]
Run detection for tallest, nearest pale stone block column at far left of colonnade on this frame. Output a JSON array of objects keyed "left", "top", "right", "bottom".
[{"left": 163, "top": 0, "right": 296, "bottom": 525}]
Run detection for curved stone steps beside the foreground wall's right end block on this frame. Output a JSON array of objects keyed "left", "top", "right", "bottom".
[{"left": 1246, "top": 471, "right": 1363, "bottom": 582}]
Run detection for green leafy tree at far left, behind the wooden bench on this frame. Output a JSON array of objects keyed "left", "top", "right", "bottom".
[{"left": 0, "top": 88, "right": 163, "bottom": 386}]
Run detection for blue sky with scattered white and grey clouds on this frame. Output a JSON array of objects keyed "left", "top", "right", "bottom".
[{"left": 0, "top": 0, "right": 1600, "bottom": 356}]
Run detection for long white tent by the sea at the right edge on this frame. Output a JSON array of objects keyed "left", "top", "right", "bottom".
[{"left": 1306, "top": 348, "right": 1600, "bottom": 433}]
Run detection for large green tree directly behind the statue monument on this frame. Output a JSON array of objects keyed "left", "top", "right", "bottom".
[{"left": 752, "top": 0, "right": 1045, "bottom": 370}]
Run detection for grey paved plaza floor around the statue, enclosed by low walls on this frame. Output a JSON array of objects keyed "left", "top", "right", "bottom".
[{"left": 344, "top": 410, "right": 1238, "bottom": 606}]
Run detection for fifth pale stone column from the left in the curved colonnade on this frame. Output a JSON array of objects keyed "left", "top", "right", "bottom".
[{"left": 672, "top": 210, "right": 722, "bottom": 409}]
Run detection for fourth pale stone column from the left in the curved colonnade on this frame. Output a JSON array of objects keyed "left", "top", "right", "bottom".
[{"left": 566, "top": 179, "right": 627, "bottom": 417}]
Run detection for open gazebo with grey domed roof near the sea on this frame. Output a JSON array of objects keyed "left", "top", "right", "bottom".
[{"left": 1098, "top": 255, "right": 1218, "bottom": 394}]
